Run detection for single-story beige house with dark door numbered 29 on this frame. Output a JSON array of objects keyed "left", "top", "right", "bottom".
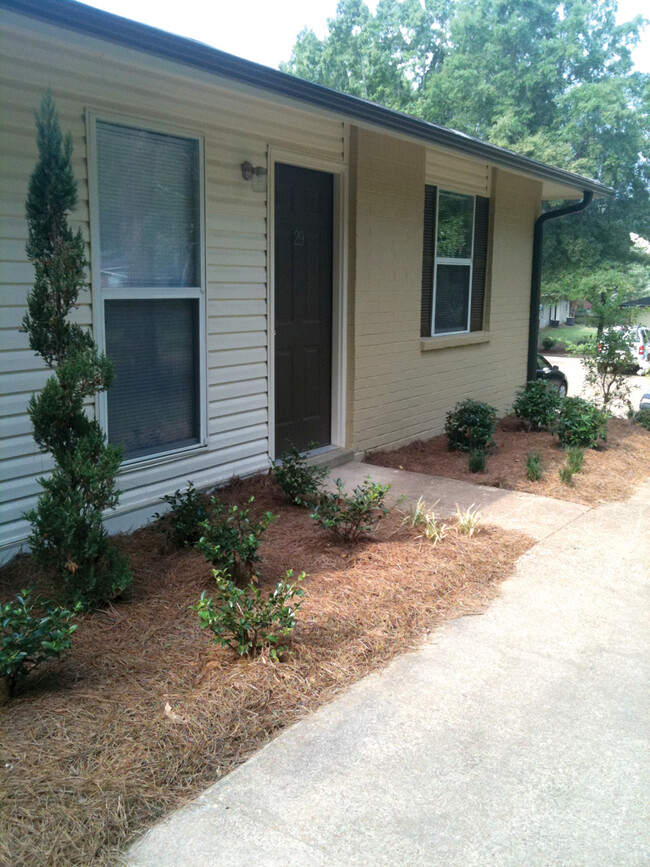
[{"left": 0, "top": 0, "right": 608, "bottom": 556}]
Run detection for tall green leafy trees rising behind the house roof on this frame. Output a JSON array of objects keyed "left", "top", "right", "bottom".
[{"left": 282, "top": 0, "right": 650, "bottom": 299}]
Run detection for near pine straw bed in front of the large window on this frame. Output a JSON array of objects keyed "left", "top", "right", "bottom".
[{"left": 0, "top": 476, "right": 532, "bottom": 867}]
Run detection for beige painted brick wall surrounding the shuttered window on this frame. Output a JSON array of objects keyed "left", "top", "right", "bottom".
[{"left": 348, "top": 130, "right": 541, "bottom": 452}]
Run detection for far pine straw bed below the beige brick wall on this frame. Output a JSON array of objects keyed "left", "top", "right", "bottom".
[{"left": 364, "top": 416, "right": 650, "bottom": 506}]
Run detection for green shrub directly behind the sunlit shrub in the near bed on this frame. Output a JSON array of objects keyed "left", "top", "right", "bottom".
[{"left": 194, "top": 497, "right": 276, "bottom": 582}]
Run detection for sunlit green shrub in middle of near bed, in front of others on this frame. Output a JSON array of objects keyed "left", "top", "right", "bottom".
[{"left": 193, "top": 569, "right": 305, "bottom": 659}]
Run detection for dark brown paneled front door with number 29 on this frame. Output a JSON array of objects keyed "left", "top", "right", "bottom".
[{"left": 275, "top": 163, "right": 334, "bottom": 457}]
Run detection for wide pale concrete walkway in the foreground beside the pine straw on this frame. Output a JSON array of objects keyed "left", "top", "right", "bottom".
[{"left": 128, "top": 467, "right": 650, "bottom": 867}]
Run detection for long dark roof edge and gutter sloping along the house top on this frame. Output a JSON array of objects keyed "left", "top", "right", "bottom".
[{"left": 0, "top": 0, "right": 614, "bottom": 197}]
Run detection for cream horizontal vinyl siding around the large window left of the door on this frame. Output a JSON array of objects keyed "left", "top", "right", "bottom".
[{"left": 0, "top": 10, "right": 346, "bottom": 546}]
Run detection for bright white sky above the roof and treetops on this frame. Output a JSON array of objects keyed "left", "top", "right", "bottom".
[{"left": 81, "top": 0, "right": 650, "bottom": 72}]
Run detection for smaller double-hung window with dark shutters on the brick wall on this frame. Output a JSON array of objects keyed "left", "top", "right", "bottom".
[{"left": 420, "top": 185, "right": 489, "bottom": 337}]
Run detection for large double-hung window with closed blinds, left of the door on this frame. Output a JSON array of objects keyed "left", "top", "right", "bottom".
[{"left": 93, "top": 119, "right": 205, "bottom": 461}]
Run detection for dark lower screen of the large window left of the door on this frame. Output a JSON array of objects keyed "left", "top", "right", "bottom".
[{"left": 104, "top": 298, "right": 200, "bottom": 459}]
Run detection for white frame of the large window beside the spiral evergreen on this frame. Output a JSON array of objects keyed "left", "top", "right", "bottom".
[{"left": 86, "top": 111, "right": 208, "bottom": 471}]
